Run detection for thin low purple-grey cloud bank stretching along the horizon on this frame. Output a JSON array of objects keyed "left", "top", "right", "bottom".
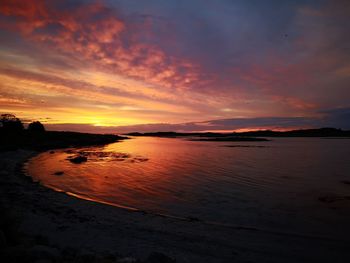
[{"left": 43, "top": 108, "right": 350, "bottom": 133}]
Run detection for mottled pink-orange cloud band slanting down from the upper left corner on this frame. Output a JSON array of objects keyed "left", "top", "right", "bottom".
[{"left": 0, "top": 1, "right": 199, "bottom": 92}]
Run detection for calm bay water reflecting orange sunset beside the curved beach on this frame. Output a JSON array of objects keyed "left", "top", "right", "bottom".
[{"left": 27, "top": 137, "right": 350, "bottom": 238}]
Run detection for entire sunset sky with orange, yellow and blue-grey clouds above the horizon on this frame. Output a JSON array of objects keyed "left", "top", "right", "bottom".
[{"left": 0, "top": 0, "right": 350, "bottom": 132}]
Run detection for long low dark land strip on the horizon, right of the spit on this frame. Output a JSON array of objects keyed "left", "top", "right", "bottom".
[{"left": 127, "top": 128, "right": 350, "bottom": 138}]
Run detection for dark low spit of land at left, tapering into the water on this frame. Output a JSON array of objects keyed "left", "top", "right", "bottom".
[{"left": 0, "top": 130, "right": 127, "bottom": 151}]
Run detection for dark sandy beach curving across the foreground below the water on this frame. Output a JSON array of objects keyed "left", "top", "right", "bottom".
[{"left": 0, "top": 150, "right": 350, "bottom": 262}]
